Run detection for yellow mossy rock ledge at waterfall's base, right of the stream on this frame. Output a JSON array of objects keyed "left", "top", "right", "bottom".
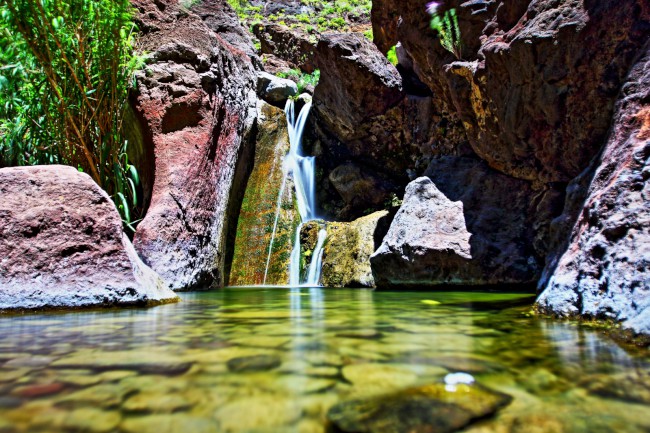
[{"left": 321, "top": 211, "right": 390, "bottom": 287}]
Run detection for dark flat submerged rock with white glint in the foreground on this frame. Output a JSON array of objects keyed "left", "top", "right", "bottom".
[{"left": 327, "top": 383, "right": 512, "bottom": 433}]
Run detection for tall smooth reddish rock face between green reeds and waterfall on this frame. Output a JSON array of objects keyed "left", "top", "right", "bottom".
[{"left": 133, "top": 0, "right": 255, "bottom": 290}]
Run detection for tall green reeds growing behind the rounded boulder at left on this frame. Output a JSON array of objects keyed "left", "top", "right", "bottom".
[{"left": 0, "top": 0, "right": 143, "bottom": 226}]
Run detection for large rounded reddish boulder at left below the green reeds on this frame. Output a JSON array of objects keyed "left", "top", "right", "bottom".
[{"left": 0, "top": 165, "right": 178, "bottom": 309}]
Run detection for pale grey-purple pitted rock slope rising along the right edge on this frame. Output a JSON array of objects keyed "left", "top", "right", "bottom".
[{"left": 537, "top": 43, "right": 650, "bottom": 334}]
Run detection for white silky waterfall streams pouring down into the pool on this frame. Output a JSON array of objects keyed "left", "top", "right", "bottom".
[{"left": 264, "top": 99, "right": 327, "bottom": 287}]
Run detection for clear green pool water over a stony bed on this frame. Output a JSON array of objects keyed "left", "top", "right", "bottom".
[{"left": 0, "top": 289, "right": 650, "bottom": 433}]
